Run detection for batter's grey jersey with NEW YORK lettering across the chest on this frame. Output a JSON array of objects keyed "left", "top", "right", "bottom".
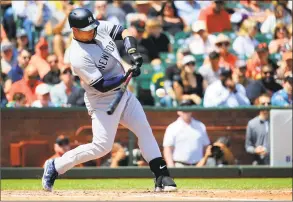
[{"left": 69, "top": 21, "right": 124, "bottom": 97}]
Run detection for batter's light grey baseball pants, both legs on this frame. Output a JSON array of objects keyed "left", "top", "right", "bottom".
[{"left": 55, "top": 91, "right": 161, "bottom": 174}]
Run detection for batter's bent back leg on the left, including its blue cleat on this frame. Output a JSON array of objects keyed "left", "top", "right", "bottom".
[{"left": 42, "top": 94, "right": 126, "bottom": 191}]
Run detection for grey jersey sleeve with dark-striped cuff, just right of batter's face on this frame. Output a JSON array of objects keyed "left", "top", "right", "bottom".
[{"left": 98, "top": 21, "right": 124, "bottom": 40}]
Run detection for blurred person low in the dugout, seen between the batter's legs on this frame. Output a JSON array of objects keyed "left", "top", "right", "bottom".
[{"left": 101, "top": 142, "right": 127, "bottom": 168}]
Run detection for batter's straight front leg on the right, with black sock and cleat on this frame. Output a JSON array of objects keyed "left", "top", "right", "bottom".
[{"left": 120, "top": 92, "right": 176, "bottom": 191}]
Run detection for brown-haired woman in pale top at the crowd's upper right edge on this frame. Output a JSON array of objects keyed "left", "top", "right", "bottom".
[{"left": 269, "top": 24, "right": 292, "bottom": 54}]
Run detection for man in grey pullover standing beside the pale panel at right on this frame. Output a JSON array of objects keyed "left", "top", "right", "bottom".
[{"left": 245, "top": 94, "right": 271, "bottom": 165}]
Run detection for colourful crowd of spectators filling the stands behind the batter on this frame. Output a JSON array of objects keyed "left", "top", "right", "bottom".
[{"left": 0, "top": 0, "right": 292, "bottom": 107}]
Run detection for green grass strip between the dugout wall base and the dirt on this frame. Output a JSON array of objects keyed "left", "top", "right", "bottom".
[{"left": 1, "top": 178, "right": 292, "bottom": 190}]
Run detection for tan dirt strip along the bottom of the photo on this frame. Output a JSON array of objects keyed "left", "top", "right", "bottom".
[{"left": 1, "top": 190, "right": 292, "bottom": 201}]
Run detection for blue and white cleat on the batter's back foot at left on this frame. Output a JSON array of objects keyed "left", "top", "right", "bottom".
[{"left": 42, "top": 159, "right": 58, "bottom": 192}]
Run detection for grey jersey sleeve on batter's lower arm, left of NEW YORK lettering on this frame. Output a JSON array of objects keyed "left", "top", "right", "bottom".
[{"left": 70, "top": 51, "right": 103, "bottom": 86}]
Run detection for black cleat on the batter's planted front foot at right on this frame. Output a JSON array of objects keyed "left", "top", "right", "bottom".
[{"left": 155, "top": 176, "right": 177, "bottom": 192}]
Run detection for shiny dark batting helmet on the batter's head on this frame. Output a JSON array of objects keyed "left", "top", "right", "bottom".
[{"left": 68, "top": 8, "right": 99, "bottom": 31}]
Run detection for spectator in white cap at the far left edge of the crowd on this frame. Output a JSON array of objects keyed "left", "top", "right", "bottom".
[{"left": 1, "top": 41, "right": 16, "bottom": 75}]
